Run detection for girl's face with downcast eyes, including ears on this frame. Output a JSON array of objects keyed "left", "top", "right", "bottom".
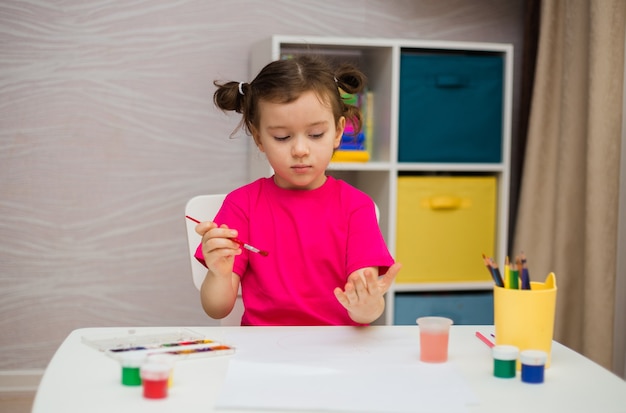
[{"left": 254, "top": 91, "right": 346, "bottom": 190}]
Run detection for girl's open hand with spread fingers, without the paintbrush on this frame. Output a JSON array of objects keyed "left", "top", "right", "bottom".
[{"left": 334, "top": 263, "right": 401, "bottom": 324}]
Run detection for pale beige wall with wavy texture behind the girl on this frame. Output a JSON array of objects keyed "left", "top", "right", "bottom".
[{"left": 0, "top": 0, "right": 523, "bottom": 370}]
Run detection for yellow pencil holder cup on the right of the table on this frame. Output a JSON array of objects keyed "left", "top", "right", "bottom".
[{"left": 493, "top": 273, "right": 556, "bottom": 370}]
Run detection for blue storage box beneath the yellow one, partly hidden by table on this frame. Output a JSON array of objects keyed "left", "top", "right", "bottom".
[{"left": 393, "top": 291, "right": 493, "bottom": 325}]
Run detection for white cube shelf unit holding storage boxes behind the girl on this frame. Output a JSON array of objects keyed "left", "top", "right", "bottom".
[{"left": 248, "top": 35, "right": 513, "bottom": 324}]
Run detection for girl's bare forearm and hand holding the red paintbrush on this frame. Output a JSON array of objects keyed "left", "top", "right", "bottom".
[{"left": 196, "top": 222, "right": 241, "bottom": 319}]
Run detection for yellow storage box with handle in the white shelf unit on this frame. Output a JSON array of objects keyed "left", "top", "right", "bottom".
[{"left": 396, "top": 176, "right": 497, "bottom": 283}]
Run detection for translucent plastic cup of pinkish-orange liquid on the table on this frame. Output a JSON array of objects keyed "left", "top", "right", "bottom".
[{"left": 416, "top": 317, "right": 452, "bottom": 363}]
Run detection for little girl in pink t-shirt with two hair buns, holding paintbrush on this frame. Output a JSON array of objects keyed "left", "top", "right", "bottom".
[{"left": 196, "top": 56, "right": 400, "bottom": 325}]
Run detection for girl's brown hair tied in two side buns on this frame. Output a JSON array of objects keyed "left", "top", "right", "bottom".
[{"left": 213, "top": 55, "right": 365, "bottom": 141}]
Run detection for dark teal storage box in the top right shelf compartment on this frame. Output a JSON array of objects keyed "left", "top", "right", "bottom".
[{"left": 398, "top": 51, "right": 504, "bottom": 163}]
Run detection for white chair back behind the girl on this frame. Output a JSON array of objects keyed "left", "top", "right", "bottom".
[{"left": 185, "top": 194, "right": 243, "bottom": 326}]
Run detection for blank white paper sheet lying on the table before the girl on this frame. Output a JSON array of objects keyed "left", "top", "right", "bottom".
[{"left": 216, "top": 358, "right": 477, "bottom": 413}]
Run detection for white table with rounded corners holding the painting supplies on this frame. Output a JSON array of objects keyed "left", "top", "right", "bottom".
[{"left": 33, "top": 326, "right": 626, "bottom": 413}]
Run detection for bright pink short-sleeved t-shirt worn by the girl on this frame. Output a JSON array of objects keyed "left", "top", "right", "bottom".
[{"left": 196, "top": 177, "right": 393, "bottom": 325}]
